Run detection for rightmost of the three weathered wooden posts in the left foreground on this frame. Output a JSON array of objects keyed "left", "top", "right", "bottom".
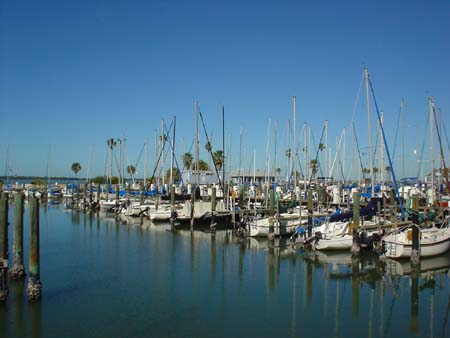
[{"left": 27, "top": 197, "right": 42, "bottom": 301}]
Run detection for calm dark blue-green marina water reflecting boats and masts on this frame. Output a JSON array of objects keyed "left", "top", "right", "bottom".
[{"left": 0, "top": 202, "right": 450, "bottom": 338}]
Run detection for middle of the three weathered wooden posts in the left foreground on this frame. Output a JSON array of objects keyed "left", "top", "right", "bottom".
[{"left": 9, "top": 193, "right": 25, "bottom": 279}]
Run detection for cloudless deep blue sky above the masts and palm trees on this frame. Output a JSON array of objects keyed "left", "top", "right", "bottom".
[{"left": 0, "top": 0, "right": 450, "bottom": 181}]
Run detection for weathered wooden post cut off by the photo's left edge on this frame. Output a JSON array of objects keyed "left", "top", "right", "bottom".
[{"left": 0, "top": 192, "right": 8, "bottom": 302}]
